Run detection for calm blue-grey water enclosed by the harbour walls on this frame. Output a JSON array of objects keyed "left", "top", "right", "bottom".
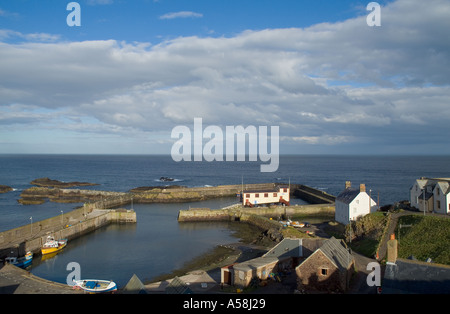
[{"left": 31, "top": 199, "right": 241, "bottom": 288}]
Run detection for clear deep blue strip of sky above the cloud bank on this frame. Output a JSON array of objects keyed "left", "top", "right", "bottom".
[{"left": 0, "top": 0, "right": 385, "bottom": 42}]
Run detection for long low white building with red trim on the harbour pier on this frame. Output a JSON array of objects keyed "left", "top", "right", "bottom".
[{"left": 242, "top": 186, "right": 290, "bottom": 207}]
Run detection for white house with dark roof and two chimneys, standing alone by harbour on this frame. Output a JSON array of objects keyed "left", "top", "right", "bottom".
[{"left": 334, "top": 181, "right": 377, "bottom": 225}]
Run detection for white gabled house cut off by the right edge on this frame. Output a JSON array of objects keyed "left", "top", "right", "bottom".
[{"left": 410, "top": 177, "right": 450, "bottom": 214}]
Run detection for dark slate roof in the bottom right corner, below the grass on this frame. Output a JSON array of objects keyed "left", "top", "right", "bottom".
[{"left": 382, "top": 259, "right": 450, "bottom": 294}]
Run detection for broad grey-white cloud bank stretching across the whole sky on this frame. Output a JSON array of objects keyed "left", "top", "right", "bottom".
[{"left": 0, "top": 0, "right": 450, "bottom": 153}]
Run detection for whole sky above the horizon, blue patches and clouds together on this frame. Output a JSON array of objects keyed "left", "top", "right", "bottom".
[{"left": 0, "top": 0, "right": 450, "bottom": 155}]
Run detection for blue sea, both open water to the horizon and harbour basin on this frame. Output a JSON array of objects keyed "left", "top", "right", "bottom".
[{"left": 0, "top": 155, "right": 450, "bottom": 287}]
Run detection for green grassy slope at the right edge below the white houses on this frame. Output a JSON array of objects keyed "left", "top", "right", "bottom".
[{"left": 396, "top": 215, "right": 450, "bottom": 265}]
